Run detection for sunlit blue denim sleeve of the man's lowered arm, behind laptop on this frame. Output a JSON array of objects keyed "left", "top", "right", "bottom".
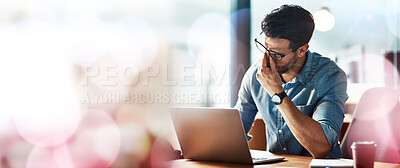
[{"left": 235, "top": 68, "right": 258, "bottom": 141}]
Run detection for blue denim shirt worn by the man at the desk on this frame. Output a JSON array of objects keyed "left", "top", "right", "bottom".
[{"left": 235, "top": 51, "right": 348, "bottom": 158}]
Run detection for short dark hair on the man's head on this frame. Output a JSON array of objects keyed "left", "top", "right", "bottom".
[{"left": 261, "top": 5, "right": 315, "bottom": 50}]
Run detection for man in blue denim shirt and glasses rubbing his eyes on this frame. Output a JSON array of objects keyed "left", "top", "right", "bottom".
[{"left": 235, "top": 5, "right": 348, "bottom": 158}]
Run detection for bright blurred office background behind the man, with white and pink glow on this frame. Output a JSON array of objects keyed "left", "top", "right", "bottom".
[{"left": 0, "top": 0, "right": 400, "bottom": 167}]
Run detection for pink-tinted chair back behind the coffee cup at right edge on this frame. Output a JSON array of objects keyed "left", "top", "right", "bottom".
[{"left": 341, "top": 87, "right": 400, "bottom": 163}]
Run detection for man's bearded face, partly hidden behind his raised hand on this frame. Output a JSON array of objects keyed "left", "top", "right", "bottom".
[{"left": 265, "top": 37, "right": 297, "bottom": 74}]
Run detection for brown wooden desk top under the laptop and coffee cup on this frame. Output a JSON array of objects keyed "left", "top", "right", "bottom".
[{"left": 168, "top": 154, "right": 400, "bottom": 168}]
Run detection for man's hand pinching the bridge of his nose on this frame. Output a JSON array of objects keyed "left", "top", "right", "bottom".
[{"left": 257, "top": 53, "right": 283, "bottom": 96}]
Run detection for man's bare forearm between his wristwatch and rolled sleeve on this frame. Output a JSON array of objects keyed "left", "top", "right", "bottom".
[{"left": 278, "top": 97, "right": 331, "bottom": 158}]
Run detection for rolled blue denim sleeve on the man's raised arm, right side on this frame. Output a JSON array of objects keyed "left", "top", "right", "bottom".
[{"left": 313, "top": 71, "right": 348, "bottom": 149}]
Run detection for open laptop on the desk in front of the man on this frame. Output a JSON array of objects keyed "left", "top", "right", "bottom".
[{"left": 171, "top": 107, "right": 285, "bottom": 164}]
